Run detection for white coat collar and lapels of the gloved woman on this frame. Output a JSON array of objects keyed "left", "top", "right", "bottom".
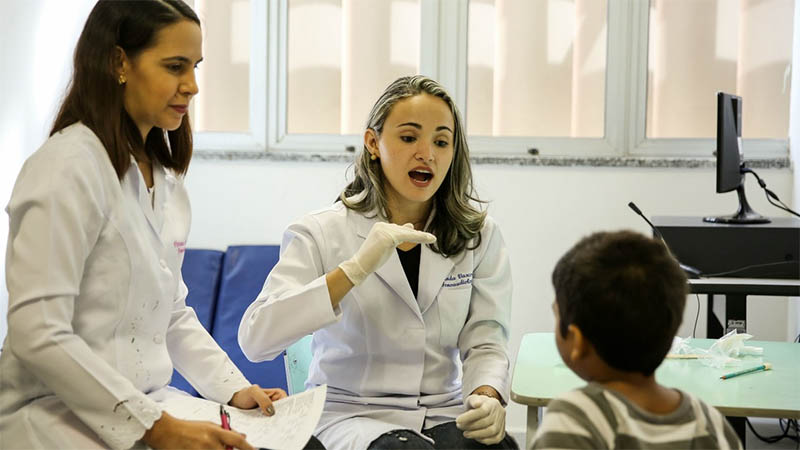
[{"left": 353, "top": 200, "right": 454, "bottom": 320}]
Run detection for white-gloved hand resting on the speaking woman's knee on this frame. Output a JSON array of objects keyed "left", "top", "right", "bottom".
[{"left": 456, "top": 394, "right": 506, "bottom": 445}]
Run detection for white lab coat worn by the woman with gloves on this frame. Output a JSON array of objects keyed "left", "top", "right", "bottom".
[{"left": 239, "top": 203, "right": 512, "bottom": 450}]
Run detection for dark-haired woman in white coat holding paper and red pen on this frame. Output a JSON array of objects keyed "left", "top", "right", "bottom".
[{"left": 0, "top": 0, "right": 286, "bottom": 449}]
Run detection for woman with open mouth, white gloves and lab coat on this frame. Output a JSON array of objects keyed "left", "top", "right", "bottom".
[{"left": 239, "top": 76, "right": 516, "bottom": 450}]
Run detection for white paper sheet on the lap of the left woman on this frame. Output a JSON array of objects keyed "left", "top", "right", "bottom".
[{"left": 161, "top": 385, "right": 327, "bottom": 450}]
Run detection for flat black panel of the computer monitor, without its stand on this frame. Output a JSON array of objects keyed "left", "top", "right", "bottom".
[{"left": 717, "top": 92, "right": 742, "bottom": 193}]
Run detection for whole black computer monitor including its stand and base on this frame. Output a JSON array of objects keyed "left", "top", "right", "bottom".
[{"left": 703, "top": 92, "right": 770, "bottom": 223}]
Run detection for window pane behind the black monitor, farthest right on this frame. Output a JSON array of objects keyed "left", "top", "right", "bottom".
[{"left": 646, "top": 0, "right": 795, "bottom": 139}]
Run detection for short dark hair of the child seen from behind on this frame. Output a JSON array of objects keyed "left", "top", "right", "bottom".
[{"left": 553, "top": 231, "right": 688, "bottom": 376}]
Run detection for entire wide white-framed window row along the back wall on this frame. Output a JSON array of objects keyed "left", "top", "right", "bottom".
[{"left": 193, "top": 0, "right": 795, "bottom": 157}]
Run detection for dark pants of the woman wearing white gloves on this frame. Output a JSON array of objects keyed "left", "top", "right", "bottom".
[{"left": 368, "top": 422, "right": 519, "bottom": 450}]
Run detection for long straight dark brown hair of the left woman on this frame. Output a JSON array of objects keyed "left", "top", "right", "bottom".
[{"left": 50, "top": 0, "right": 200, "bottom": 179}]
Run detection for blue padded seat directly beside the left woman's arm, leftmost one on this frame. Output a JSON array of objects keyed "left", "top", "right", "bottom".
[{"left": 170, "top": 249, "right": 224, "bottom": 397}]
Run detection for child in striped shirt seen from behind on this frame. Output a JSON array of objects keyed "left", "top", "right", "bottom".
[{"left": 533, "top": 231, "right": 742, "bottom": 449}]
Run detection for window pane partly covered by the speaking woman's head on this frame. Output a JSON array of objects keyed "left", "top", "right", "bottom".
[{"left": 286, "top": 0, "right": 420, "bottom": 134}]
